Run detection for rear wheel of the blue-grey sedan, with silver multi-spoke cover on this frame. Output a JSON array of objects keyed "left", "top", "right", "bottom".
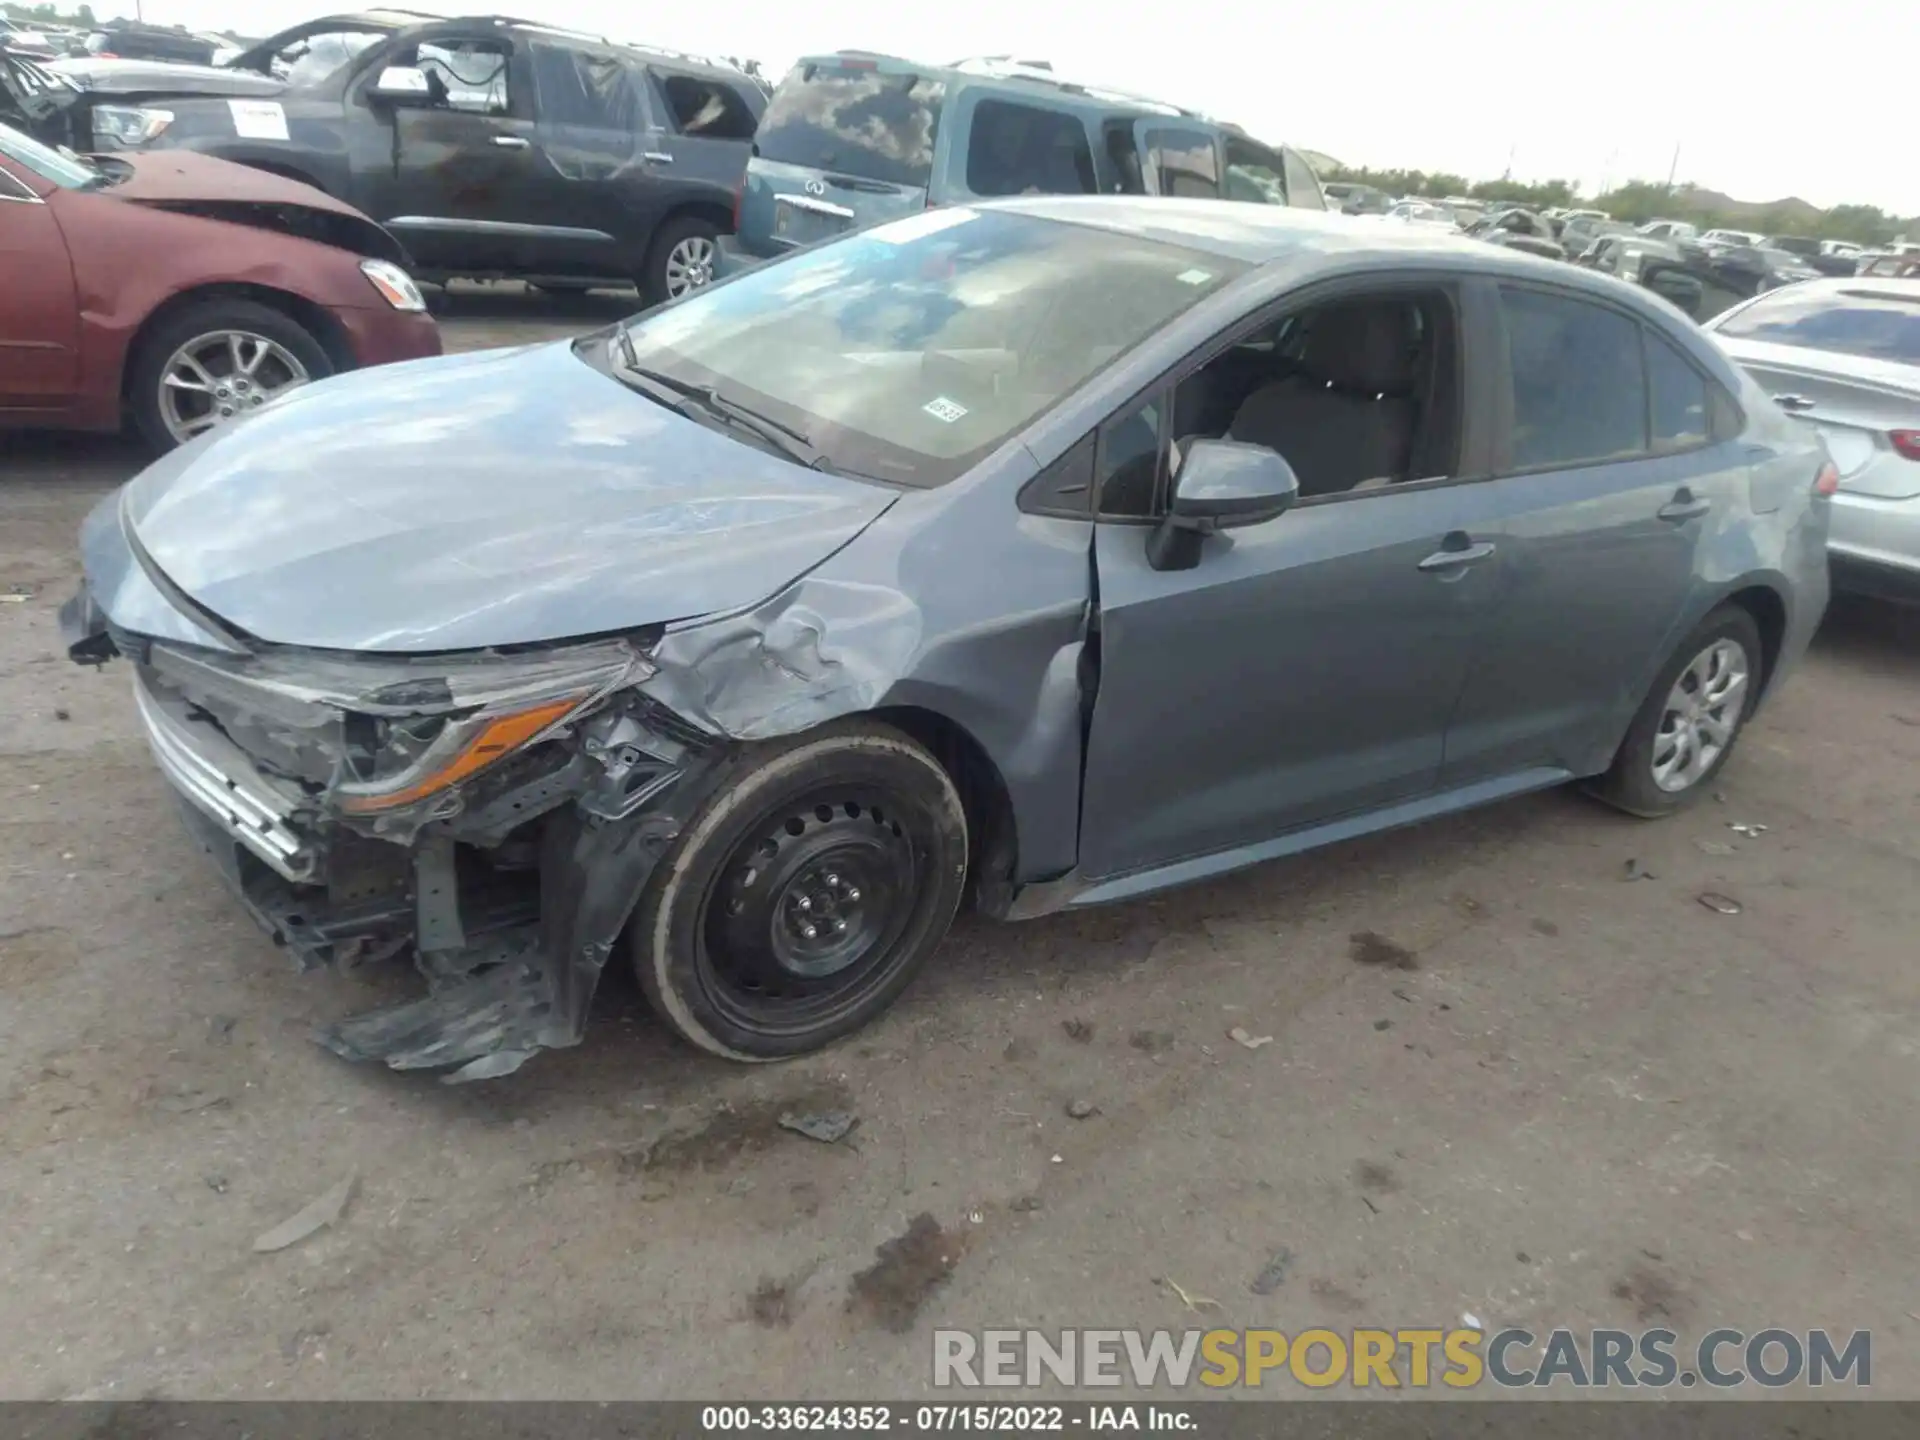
[{"left": 1592, "top": 605, "right": 1763, "bottom": 818}]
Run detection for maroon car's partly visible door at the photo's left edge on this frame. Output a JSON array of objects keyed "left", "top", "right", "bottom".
[{"left": 0, "top": 161, "right": 81, "bottom": 411}]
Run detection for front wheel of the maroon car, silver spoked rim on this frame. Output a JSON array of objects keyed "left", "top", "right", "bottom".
[{"left": 129, "top": 300, "right": 334, "bottom": 449}]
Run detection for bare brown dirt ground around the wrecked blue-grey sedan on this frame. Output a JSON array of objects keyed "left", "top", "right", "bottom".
[{"left": 0, "top": 294, "right": 1920, "bottom": 1398}]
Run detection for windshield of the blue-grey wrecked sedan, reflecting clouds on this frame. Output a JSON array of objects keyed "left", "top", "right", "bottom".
[{"left": 614, "top": 207, "right": 1246, "bottom": 488}]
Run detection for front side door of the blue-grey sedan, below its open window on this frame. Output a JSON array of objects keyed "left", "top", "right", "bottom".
[{"left": 1079, "top": 278, "right": 1498, "bottom": 879}]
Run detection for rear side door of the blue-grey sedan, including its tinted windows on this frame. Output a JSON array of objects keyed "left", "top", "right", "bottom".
[{"left": 1442, "top": 284, "right": 1753, "bottom": 787}]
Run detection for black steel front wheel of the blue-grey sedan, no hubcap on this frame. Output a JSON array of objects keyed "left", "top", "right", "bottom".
[{"left": 628, "top": 722, "right": 968, "bottom": 1060}]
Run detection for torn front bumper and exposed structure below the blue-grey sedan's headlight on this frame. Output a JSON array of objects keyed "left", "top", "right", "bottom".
[{"left": 80, "top": 591, "right": 735, "bottom": 1081}]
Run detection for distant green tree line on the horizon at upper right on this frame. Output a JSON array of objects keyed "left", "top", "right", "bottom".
[{"left": 1321, "top": 165, "right": 1920, "bottom": 246}]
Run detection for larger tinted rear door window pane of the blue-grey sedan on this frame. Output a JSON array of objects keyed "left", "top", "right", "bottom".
[{"left": 1500, "top": 288, "right": 1647, "bottom": 470}]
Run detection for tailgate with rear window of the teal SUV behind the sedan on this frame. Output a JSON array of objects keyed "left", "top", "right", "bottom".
[{"left": 737, "top": 58, "right": 947, "bottom": 255}]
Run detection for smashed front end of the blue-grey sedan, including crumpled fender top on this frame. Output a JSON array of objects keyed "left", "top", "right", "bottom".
[{"left": 61, "top": 564, "right": 952, "bottom": 1083}]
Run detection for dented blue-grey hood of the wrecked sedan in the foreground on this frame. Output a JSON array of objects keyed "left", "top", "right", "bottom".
[{"left": 123, "top": 344, "right": 895, "bottom": 653}]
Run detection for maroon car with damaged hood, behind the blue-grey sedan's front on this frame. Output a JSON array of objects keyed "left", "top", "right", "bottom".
[{"left": 0, "top": 125, "right": 440, "bottom": 449}]
